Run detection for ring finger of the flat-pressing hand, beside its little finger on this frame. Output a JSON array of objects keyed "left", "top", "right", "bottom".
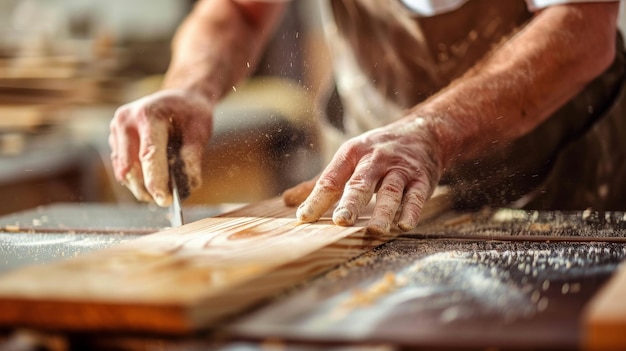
[{"left": 367, "top": 171, "right": 407, "bottom": 235}]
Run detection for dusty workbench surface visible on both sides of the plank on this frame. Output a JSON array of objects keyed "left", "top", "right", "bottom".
[{"left": 0, "top": 204, "right": 626, "bottom": 350}]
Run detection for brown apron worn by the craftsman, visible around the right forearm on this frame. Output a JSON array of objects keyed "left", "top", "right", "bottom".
[{"left": 323, "top": 0, "right": 626, "bottom": 209}]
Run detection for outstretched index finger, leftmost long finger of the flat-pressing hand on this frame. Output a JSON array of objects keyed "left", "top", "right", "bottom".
[{"left": 296, "top": 147, "right": 356, "bottom": 223}]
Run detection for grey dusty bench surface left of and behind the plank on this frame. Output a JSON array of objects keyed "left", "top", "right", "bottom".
[{"left": 0, "top": 203, "right": 236, "bottom": 273}]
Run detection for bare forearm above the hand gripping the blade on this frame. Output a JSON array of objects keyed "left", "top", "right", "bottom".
[{"left": 163, "top": 0, "right": 284, "bottom": 101}]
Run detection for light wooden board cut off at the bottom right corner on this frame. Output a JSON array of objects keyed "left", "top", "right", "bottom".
[{"left": 583, "top": 263, "right": 626, "bottom": 350}]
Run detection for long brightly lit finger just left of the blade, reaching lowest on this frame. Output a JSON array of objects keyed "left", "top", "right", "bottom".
[{"left": 139, "top": 118, "right": 172, "bottom": 207}]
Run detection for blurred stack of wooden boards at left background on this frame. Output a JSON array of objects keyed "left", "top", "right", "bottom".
[{"left": 0, "top": 53, "right": 128, "bottom": 132}]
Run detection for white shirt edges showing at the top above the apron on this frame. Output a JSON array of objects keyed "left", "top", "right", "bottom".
[{"left": 400, "top": 0, "right": 619, "bottom": 17}]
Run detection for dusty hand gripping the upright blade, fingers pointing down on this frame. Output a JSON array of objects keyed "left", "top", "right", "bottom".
[{"left": 109, "top": 90, "right": 213, "bottom": 206}]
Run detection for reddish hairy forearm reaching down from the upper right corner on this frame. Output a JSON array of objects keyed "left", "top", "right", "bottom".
[{"left": 411, "top": 2, "right": 618, "bottom": 165}]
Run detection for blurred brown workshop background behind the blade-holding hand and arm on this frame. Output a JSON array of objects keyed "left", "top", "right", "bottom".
[{"left": 0, "top": 0, "right": 626, "bottom": 214}]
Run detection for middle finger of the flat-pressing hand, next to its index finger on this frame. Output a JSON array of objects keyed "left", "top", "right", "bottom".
[{"left": 333, "top": 155, "right": 384, "bottom": 226}]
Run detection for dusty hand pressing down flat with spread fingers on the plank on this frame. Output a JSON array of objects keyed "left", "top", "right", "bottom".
[{"left": 296, "top": 117, "right": 443, "bottom": 234}]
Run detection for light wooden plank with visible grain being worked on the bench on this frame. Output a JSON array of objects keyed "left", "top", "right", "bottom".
[{"left": 0, "top": 195, "right": 446, "bottom": 334}]
